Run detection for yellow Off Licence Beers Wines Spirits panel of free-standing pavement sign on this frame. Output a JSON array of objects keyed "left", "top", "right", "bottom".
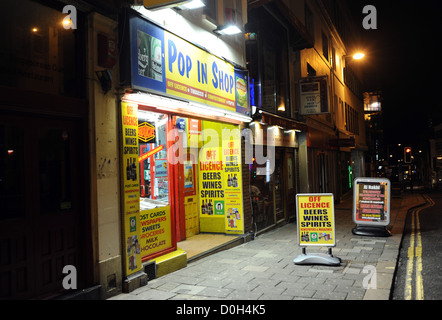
[{"left": 296, "top": 194, "right": 336, "bottom": 247}]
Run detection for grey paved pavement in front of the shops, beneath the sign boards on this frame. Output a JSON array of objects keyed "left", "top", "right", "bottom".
[{"left": 109, "top": 193, "right": 425, "bottom": 301}]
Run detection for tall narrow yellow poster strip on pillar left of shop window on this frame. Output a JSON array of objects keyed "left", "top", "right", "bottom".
[{"left": 121, "top": 102, "right": 142, "bottom": 276}]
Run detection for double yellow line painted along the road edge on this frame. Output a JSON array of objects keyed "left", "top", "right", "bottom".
[{"left": 405, "top": 195, "right": 434, "bottom": 300}]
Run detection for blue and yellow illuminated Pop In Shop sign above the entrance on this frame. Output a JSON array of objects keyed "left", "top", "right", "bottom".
[{"left": 130, "top": 17, "right": 249, "bottom": 114}]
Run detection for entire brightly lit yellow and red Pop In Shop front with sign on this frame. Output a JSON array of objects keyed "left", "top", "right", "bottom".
[{"left": 120, "top": 11, "right": 251, "bottom": 276}]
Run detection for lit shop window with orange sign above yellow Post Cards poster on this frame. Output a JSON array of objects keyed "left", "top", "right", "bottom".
[{"left": 137, "top": 106, "right": 174, "bottom": 261}]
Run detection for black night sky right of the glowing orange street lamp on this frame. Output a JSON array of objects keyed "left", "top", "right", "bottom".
[{"left": 347, "top": 0, "right": 442, "bottom": 146}]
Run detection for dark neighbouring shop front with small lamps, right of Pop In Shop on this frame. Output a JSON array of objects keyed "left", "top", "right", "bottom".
[{"left": 249, "top": 110, "right": 306, "bottom": 233}]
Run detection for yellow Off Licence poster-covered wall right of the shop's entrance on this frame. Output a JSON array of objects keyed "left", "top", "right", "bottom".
[{"left": 198, "top": 121, "right": 244, "bottom": 234}]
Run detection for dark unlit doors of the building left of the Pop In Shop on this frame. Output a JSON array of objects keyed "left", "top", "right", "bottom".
[{"left": 0, "top": 115, "right": 87, "bottom": 299}]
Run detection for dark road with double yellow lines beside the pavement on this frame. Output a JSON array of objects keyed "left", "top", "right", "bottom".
[{"left": 392, "top": 191, "right": 442, "bottom": 300}]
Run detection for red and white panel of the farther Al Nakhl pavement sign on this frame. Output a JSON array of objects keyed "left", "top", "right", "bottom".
[{"left": 353, "top": 178, "right": 391, "bottom": 226}]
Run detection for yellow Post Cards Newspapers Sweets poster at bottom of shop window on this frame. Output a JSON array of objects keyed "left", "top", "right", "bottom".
[{"left": 140, "top": 206, "right": 172, "bottom": 258}]
